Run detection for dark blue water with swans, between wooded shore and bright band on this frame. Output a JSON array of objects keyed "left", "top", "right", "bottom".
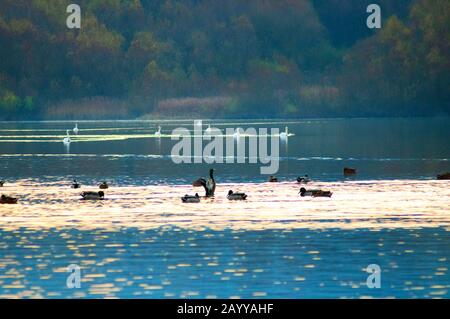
[{"left": 0, "top": 118, "right": 450, "bottom": 185}]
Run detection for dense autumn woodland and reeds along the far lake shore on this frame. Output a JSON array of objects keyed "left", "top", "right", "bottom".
[{"left": 0, "top": 0, "right": 450, "bottom": 120}]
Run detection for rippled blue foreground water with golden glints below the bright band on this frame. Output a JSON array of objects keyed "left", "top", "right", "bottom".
[{"left": 0, "top": 227, "right": 450, "bottom": 298}]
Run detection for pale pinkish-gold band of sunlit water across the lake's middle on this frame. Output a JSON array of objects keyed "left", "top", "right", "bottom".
[{"left": 0, "top": 180, "right": 450, "bottom": 230}]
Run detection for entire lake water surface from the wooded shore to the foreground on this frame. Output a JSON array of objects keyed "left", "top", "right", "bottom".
[{"left": 0, "top": 118, "right": 450, "bottom": 298}]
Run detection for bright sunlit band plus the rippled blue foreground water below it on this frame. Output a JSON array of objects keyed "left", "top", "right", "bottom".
[{"left": 0, "top": 180, "right": 450, "bottom": 298}]
